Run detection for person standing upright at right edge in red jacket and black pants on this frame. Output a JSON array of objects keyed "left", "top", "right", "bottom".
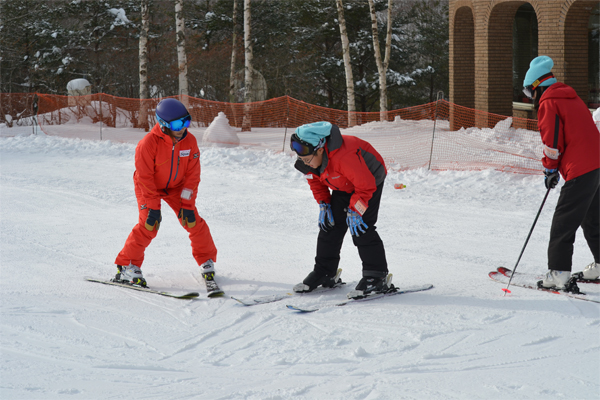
[{"left": 523, "top": 56, "right": 600, "bottom": 290}]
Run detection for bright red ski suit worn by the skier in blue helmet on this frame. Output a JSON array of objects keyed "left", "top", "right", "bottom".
[{"left": 115, "top": 124, "right": 217, "bottom": 267}]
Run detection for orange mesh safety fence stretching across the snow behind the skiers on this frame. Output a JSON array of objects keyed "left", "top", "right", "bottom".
[{"left": 2, "top": 93, "right": 542, "bottom": 174}]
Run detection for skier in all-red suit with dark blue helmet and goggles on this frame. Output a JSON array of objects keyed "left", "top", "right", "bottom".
[{"left": 115, "top": 98, "right": 217, "bottom": 286}]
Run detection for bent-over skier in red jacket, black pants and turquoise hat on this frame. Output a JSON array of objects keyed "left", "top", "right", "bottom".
[{"left": 290, "top": 122, "right": 395, "bottom": 298}]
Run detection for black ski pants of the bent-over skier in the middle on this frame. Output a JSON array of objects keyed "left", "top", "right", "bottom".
[{"left": 314, "top": 183, "right": 388, "bottom": 278}]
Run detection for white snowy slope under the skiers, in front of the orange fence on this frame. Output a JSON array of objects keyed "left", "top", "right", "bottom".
[{"left": 0, "top": 123, "right": 600, "bottom": 400}]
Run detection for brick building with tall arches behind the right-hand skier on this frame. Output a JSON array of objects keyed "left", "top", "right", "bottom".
[{"left": 449, "top": 0, "right": 600, "bottom": 127}]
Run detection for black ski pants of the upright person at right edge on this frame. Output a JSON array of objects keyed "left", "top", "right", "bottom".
[{"left": 548, "top": 169, "right": 600, "bottom": 271}]
